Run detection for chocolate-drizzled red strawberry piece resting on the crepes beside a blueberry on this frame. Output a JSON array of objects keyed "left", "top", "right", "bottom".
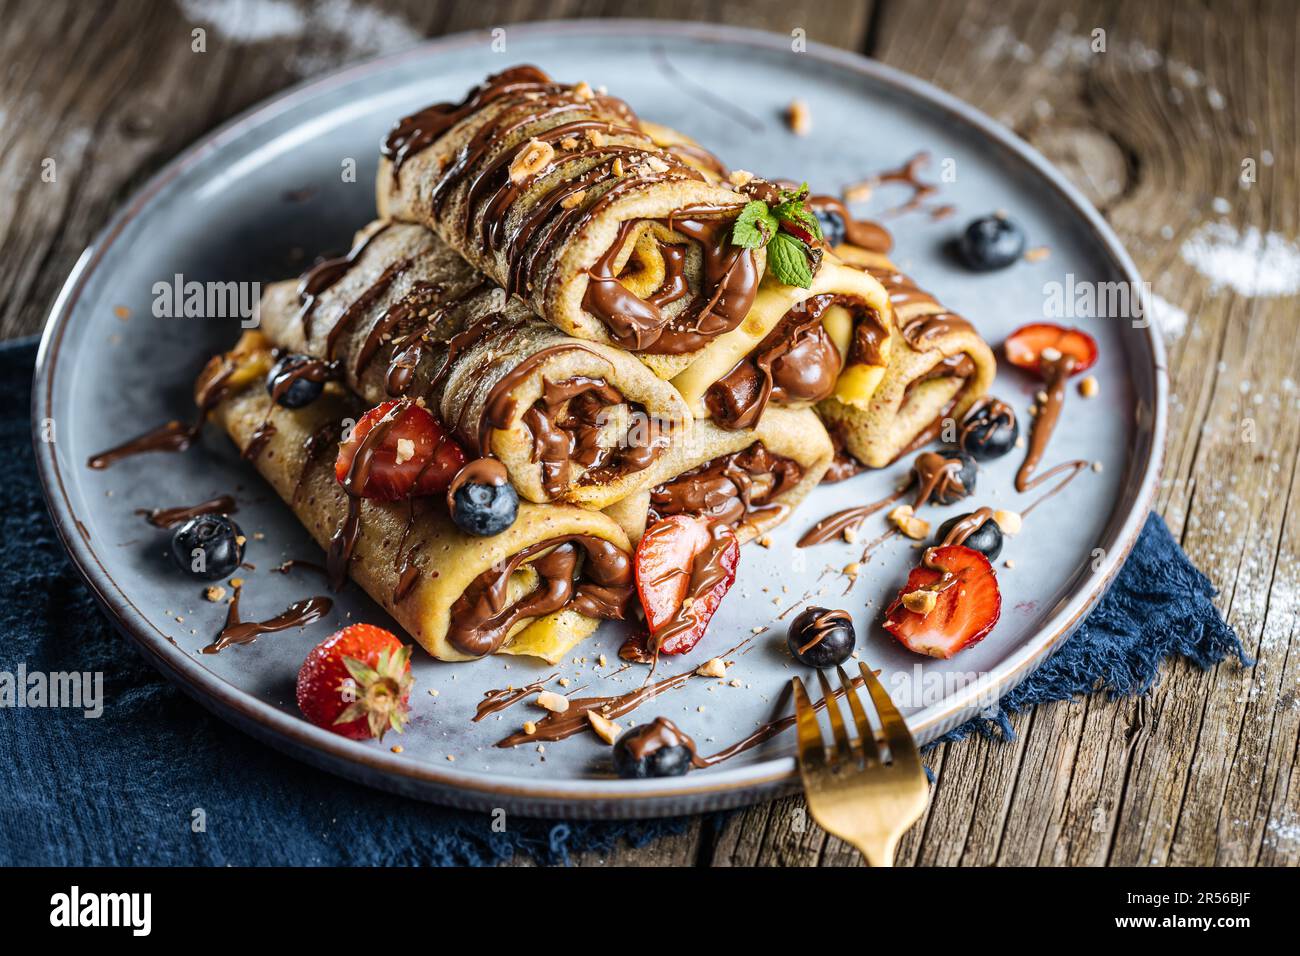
[{"left": 334, "top": 401, "right": 465, "bottom": 501}]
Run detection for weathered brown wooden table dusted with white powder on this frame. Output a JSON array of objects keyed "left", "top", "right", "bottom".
[{"left": 0, "top": 0, "right": 1300, "bottom": 865}]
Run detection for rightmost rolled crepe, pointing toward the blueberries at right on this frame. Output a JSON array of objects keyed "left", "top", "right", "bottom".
[{"left": 818, "top": 243, "right": 997, "bottom": 468}]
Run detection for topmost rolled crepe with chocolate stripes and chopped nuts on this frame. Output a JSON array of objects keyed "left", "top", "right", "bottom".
[{"left": 377, "top": 66, "right": 766, "bottom": 378}]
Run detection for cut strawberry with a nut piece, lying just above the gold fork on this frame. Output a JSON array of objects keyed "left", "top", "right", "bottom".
[{"left": 884, "top": 545, "right": 1002, "bottom": 659}]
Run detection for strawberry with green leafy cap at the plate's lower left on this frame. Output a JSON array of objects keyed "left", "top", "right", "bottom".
[{"left": 298, "top": 624, "right": 415, "bottom": 740}]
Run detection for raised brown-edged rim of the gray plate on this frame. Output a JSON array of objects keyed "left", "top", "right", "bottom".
[{"left": 31, "top": 18, "right": 1169, "bottom": 818}]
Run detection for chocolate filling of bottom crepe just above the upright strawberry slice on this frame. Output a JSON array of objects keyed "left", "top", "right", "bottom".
[{"left": 649, "top": 441, "right": 803, "bottom": 527}]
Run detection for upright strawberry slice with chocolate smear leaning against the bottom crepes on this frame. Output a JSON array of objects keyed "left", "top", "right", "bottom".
[{"left": 633, "top": 515, "right": 740, "bottom": 654}]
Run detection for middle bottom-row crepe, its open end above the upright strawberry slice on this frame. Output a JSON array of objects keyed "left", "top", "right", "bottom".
[{"left": 606, "top": 408, "right": 835, "bottom": 544}]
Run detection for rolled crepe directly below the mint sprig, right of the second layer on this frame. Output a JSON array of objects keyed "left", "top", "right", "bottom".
[{"left": 672, "top": 254, "right": 893, "bottom": 428}]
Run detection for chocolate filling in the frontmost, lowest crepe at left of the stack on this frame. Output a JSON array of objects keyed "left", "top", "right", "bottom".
[{"left": 447, "top": 535, "right": 633, "bottom": 657}]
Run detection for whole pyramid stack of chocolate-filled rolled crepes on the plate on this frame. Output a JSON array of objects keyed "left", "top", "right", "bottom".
[{"left": 205, "top": 66, "right": 992, "bottom": 661}]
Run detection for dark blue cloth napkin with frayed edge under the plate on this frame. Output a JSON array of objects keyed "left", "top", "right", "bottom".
[{"left": 0, "top": 341, "right": 1245, "bottom": 866}]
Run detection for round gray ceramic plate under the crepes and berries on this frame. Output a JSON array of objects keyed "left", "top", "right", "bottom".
[{"left": 33, "top": 21, "right": 1166, "bottom": 817}]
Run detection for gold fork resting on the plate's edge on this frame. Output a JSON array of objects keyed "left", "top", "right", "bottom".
[{"left": 794, "top": 663, "right": 930, "bottom": 866}]
